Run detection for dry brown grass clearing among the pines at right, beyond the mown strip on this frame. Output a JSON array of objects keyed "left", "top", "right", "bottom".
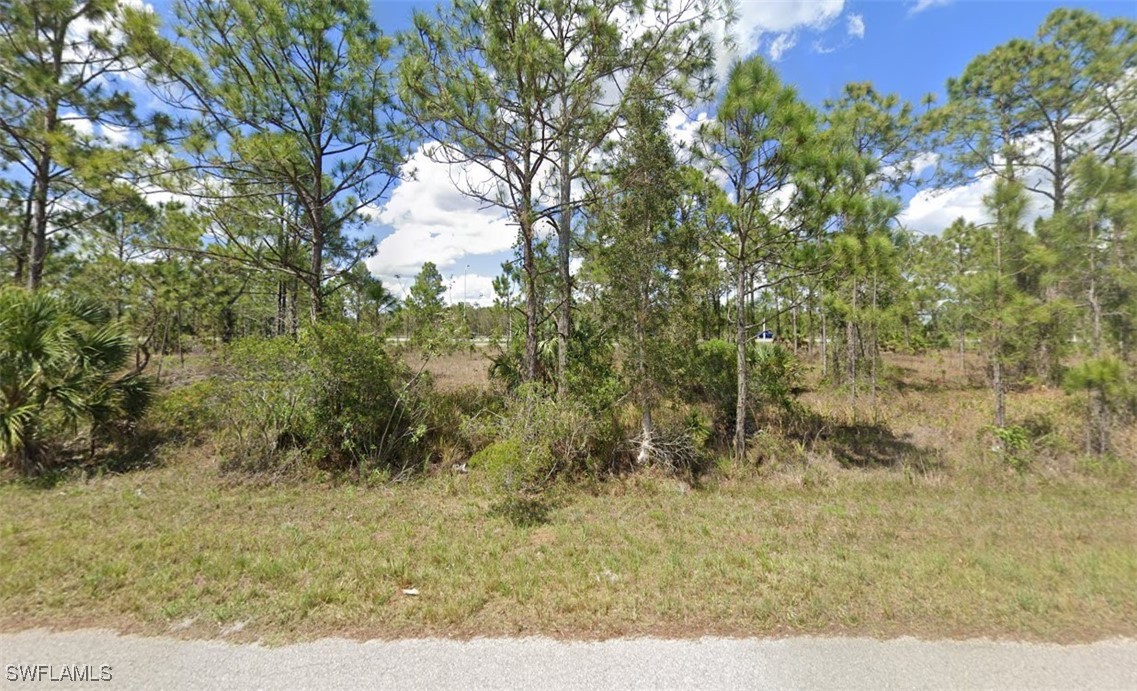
[{"left": 790, "top": 352, "right": 1137, "bottom": 485}]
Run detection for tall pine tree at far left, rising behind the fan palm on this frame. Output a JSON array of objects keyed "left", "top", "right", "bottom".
[{"left": 0, "top": 0, "right": 157, "bottom": 289}]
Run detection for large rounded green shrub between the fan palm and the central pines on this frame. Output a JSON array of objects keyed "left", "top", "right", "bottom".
[{"left": 214, "top": 324, "right": 426, "bottom": 472}]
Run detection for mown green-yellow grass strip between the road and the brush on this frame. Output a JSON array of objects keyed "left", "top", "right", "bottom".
[{"left": 0, "top": 464, "right": 1137, "bottom": 642}]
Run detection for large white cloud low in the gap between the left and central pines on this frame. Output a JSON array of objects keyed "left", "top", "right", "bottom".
[{"left": 365, "top": 148, "right": 517, "bottom": 283}]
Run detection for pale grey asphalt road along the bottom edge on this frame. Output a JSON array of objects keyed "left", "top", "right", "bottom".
[{"left": 0, "top": 631, "right": 1137, "bottom": 691}]
